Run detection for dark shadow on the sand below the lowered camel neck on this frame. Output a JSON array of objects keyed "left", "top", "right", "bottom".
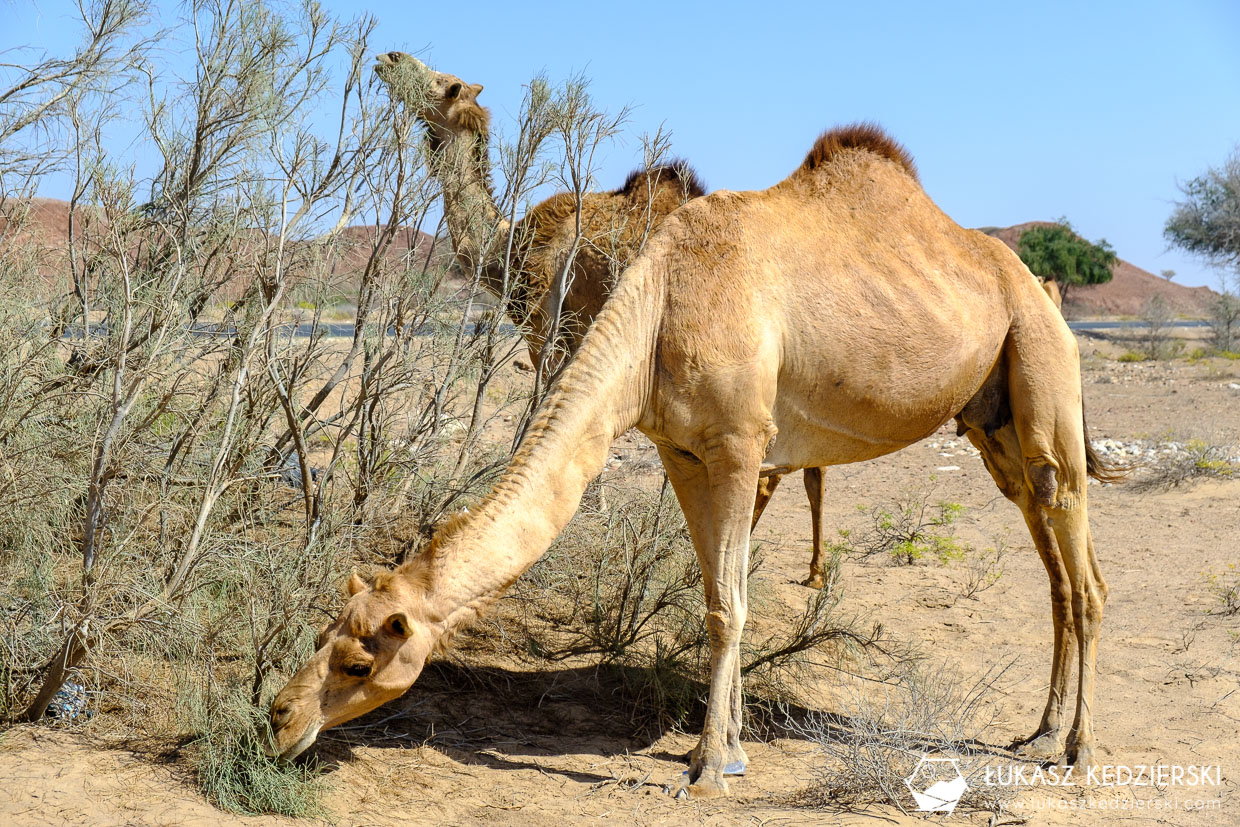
[{"left": 306, "top": 661, "right": 1012, "bottom": 784}]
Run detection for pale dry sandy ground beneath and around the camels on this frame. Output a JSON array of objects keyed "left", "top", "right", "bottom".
[{"left": 0, "top": 340, "right": 1240, "bottom": 825}]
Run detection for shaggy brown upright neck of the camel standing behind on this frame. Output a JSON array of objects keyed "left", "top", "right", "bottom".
[{"left": 430, "top": 130, "right": 508, "bottom": 287}]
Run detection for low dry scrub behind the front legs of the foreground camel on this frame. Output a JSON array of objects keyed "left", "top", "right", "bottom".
[{"left": 483, "top": 479, "right": 892, "bottom": 729}]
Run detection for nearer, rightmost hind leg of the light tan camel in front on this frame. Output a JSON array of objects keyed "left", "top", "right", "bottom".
[{"left": 1004, "top": 315, "right": 1107, "bottom": 767}]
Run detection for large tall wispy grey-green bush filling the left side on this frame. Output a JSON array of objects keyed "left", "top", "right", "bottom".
[{"left": 0, "top": 0, "right": 553, "bottom": 813}]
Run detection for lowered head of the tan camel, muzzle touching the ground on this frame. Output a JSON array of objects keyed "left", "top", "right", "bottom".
[{"left": 270, "top": 569, "right": 443, "bottom": 760}]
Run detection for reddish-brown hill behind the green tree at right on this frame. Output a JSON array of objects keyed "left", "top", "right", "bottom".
[{"left": 981, "top": 221, "right": 1219, "bottom": 319}]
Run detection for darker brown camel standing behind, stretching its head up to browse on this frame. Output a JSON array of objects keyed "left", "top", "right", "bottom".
[{"left": 374, "top": 52, "right": 827, "bottom": 589}]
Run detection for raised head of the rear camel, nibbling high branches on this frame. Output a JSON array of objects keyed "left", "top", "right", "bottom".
[{"left": 374, "top": 52, "right": 491, "bottom": 139}]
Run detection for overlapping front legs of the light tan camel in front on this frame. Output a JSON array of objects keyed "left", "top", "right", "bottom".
[{"left": 662, "top": 438, "right": 765, "bottom": 798}]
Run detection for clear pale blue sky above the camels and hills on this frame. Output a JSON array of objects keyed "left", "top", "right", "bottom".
[{"left": 0, "top": 0, "right": 1240, "bottom": 285}]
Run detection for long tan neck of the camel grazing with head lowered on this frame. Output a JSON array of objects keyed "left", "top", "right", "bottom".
[{"left": 418, "top": 262, "right": 662, "bottom": 630}]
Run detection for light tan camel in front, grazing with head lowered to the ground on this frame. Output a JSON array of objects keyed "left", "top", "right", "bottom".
[{"left": 270, "top": 124, "right": 1112, "bottom": 797}]
